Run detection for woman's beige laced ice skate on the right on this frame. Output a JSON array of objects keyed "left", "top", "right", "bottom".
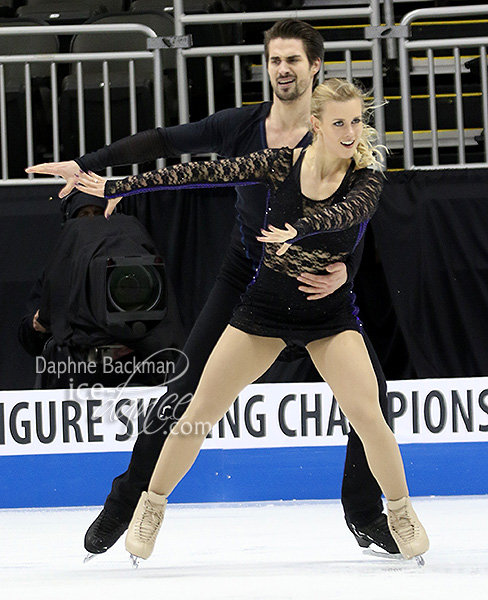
[{"left": 388, "top": 496, "right": 429, "bottom": 565}]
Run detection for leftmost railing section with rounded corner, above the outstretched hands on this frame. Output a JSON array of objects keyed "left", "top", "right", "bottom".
[{"left": 0, "top": 24, "right": 164, "bottom": 185}]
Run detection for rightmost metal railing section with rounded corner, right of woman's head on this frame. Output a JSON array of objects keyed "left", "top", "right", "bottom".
[{"left": 399, "top": 5, "right": 488, "bottom": 169}]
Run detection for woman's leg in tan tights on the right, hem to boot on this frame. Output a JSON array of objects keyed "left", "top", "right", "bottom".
[{"left": 307, "top": 331, "right": 408, "bottom": 500}]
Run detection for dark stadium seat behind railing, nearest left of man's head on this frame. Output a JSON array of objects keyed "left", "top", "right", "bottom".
[{"left": 60, "top": 12, "right": 177, "bottom": 162}]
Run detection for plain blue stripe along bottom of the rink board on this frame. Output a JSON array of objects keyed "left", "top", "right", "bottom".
[{"left": 0, "top": 442, "right": 488, "bottom": 508}]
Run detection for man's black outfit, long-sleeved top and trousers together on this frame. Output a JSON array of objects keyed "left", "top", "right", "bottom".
[{"left": 77, "top": 102, "right": 388, "bottom": 532}]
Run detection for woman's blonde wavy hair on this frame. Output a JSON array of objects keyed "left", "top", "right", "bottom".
[{"left": 311, "top": 77, "right": 385, "bottom": 169}]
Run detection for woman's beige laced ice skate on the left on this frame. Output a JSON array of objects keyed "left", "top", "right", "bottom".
[{"left": 125, "top": 492, "right": 168, "bottom": 567}]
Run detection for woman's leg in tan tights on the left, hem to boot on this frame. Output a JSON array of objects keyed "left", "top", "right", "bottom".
[{"left": 148, "top": 325, "right": 285, "bottom": 496}]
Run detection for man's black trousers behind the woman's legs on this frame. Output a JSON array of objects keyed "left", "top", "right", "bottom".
[{"left": 105, "top": 246, "right": 387, "bottom": 525}]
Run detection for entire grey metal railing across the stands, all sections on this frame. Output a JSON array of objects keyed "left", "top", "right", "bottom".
[{"left": 0, "top": 0, "right": 488, "bottom": 180}]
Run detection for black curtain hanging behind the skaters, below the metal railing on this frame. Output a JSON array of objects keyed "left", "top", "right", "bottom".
[{"left": 0, "top": 169, "right": 488, "bottom": 389}]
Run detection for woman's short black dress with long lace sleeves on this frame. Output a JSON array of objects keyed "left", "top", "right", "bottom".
[{"left": 105, "top": 148, "right": 382, "bottom": 346}]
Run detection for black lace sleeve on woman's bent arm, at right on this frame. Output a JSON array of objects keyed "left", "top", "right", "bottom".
[{"left": 290, "top": 169, "right": 383, "bottom": 243}]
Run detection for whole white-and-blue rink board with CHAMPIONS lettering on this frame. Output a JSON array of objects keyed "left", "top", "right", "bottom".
[{"left": 0, "top": 378, "right": 488, "bottom": 508}]
